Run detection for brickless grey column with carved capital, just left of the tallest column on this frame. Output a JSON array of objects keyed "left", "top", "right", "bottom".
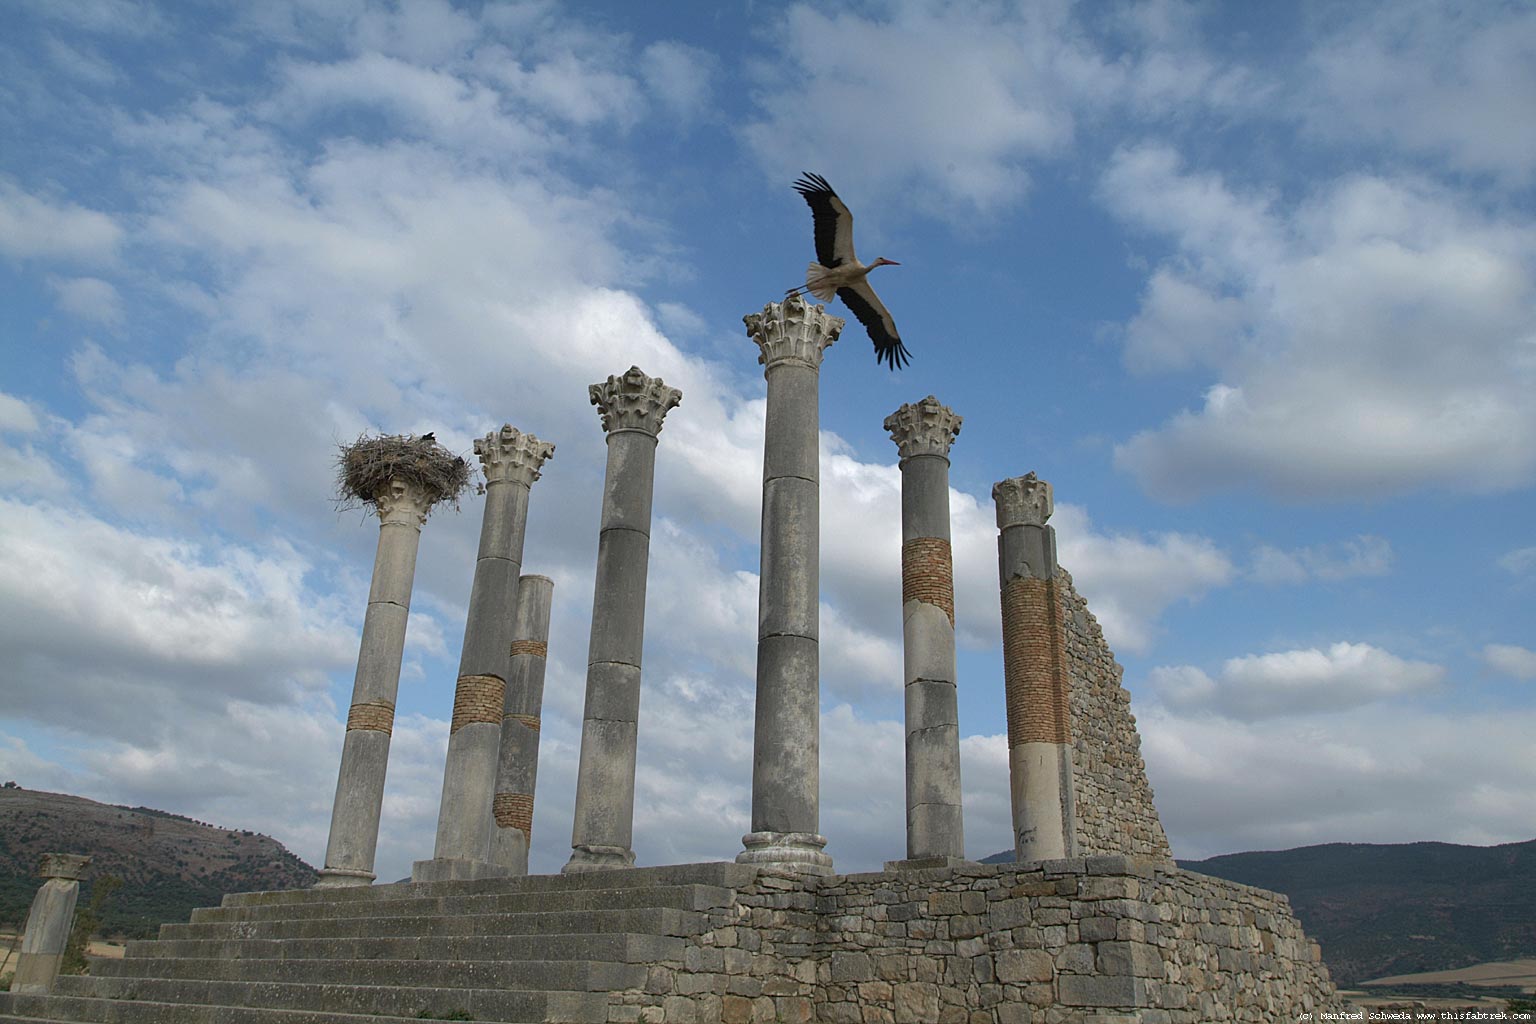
[{"left": 564, "top": 367, "right": 682, "bottom": 872}]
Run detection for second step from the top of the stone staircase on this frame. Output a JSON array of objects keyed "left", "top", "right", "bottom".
[{"left": 181, "top": 883, "right": 733, "bottom": 938}]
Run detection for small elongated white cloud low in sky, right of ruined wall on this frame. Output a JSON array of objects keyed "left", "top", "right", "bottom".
[{"left": 1149, "top": 642, "right": 1445, "bottom": 722}]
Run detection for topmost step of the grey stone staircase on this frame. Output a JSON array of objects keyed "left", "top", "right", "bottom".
[{"left": 221, "top": 861, "right": 757, "bottom": 907}]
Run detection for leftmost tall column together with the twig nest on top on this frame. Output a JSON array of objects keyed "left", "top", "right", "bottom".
[{"left": 315, "top": 438, "right": 454, "bottom": 889}]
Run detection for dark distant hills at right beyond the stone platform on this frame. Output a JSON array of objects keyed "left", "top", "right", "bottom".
[{"left": 986, "top": 840, "right": 1536, "bottom": 986}]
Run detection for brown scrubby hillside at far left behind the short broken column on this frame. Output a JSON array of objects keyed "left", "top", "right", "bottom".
[{"left": 0, "top": 783, "right": 315, "bottom": 936}]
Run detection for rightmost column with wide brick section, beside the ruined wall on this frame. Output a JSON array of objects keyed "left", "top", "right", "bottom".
[{"left": 992, "top": 473, "right": 1077, "bottom": 861}]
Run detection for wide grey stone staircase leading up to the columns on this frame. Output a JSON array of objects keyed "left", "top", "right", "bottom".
[{"left": 0, "top": 863, "right": 756, "bottom": 1024}]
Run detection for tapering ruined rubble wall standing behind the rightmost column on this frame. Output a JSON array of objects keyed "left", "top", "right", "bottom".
[{"left": 1057, "top": 570, "right": 1174, "bottom": 858}]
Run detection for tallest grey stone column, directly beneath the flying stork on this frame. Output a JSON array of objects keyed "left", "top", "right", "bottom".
[{"left": 736, "top": 296, "right": 843, "bottom": 875}]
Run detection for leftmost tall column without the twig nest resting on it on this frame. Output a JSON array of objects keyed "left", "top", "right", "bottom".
[{"left": 315, "top": 477, "right": 432, "bottom": 889}]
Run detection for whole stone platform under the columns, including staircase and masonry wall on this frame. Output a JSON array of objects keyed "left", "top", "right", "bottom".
[{"left": 0, "top": 857, "right": 1341, "bottom": 1024}]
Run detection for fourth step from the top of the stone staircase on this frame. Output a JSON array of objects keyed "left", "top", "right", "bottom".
[{"left": 119, "top": 932, "right": 687, "bottom": 976}]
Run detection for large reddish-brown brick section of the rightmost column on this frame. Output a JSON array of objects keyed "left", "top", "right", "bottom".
[{"left": 1003, "top": 576, "right": 1072, "bottom": 746}]
